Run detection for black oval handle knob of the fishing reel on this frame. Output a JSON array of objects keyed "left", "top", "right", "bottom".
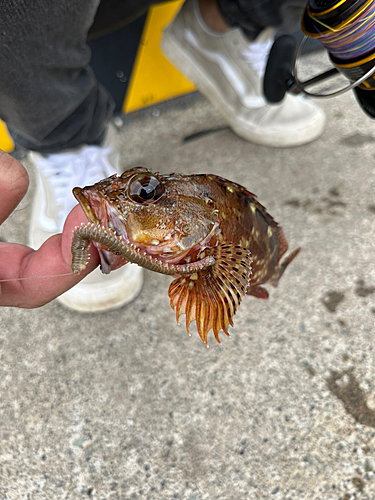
[{"left": 263, "top": 35, "right": 297, "bottom": 104}]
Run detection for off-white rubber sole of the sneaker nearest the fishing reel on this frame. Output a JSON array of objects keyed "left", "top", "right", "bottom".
[{"left": 161, "top": 26, "right": 325, "bottom": 148}]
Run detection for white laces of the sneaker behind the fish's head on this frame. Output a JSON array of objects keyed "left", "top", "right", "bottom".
[{"left": 38, "top": 146, "right": 118, "bottom": 231}]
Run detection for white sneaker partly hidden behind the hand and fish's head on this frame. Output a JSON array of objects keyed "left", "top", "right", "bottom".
[{"left": 29, "top": 125, "right": 143, "bottom": 312}]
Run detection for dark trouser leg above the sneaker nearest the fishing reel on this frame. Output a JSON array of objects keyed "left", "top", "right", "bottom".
[{"left": 217, "top": 0, "right": 307, "bottom": 39}]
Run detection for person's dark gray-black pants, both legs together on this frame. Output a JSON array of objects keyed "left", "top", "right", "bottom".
[{"left": 0, "top": 0, "right": 305, "bottom": 154}]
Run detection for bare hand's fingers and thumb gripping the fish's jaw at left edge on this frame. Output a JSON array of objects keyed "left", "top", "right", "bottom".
[{"left": 0, "top": 150, "right": 99, "bottom": 309}]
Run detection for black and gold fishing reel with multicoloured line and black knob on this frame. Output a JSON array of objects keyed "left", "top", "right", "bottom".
[{"left": 263, "top": 0, "right": 375, "bottom": 119}]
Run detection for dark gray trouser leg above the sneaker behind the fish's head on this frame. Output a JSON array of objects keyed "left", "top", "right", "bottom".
[{"left": 0, "top": 0, "right": 114, "bottom": 153}]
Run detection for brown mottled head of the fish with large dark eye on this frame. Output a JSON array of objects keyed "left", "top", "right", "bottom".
[{"left": 73, "top": 167, "right": 218, "bottom": 270}]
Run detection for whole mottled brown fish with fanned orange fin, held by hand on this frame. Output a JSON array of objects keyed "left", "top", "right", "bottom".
[{"left": 71, "top": 167, "right": 300, "bottom": 345}]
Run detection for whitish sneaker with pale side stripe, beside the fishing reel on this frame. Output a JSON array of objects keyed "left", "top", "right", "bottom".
[{"left": 161, "top": 0, "right": 325, "bottom": 147}]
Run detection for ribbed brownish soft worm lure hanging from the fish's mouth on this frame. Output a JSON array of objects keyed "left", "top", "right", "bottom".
[{"left": 71, "top": 223, "right": 215, "bottom": 276}]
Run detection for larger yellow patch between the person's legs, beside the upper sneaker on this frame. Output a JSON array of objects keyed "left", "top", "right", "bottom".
[{"left": 123, "top": 1, "right": 195, "bottom": 113}]
